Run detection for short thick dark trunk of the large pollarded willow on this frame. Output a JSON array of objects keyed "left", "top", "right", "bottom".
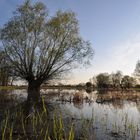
[{"left": 27, "top": 81, "right": 40, "bottom": 102}]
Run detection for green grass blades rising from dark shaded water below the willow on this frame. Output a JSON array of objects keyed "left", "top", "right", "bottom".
[{"left": 0, "top": 98, "right": 75, "bottom": 140}]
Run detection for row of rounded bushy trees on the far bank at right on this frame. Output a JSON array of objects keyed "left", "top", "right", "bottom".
[{"left": 90, "top": 71, "right": 138, "bottom": 90}]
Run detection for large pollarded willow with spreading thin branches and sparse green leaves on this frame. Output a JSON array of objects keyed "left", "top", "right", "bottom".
[{"left": 1, "top": 0, "right": 93, "bottom": 100}]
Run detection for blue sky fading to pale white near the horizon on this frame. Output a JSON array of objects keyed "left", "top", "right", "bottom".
[{"left": 0, "top": 0, "right": 140, "bottom": 83}]
